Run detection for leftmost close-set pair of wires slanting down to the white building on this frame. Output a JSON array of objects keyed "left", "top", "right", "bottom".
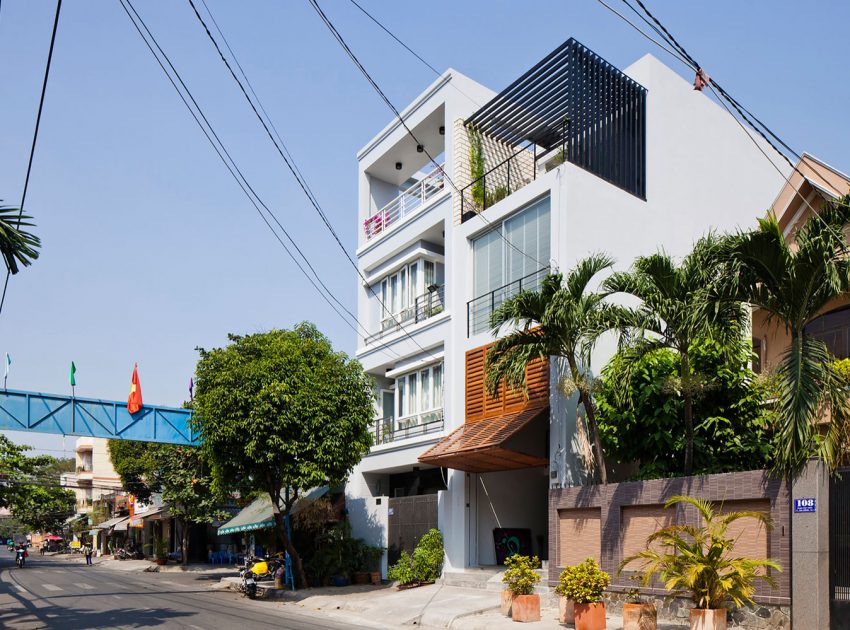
[{"left": 119, "top": 0, "right": 396, "bottom": 354}]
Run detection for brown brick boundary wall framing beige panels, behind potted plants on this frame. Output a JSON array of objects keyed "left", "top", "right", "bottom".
[{"left": 549, "top": 470, "right": 791, "bottom": 612}]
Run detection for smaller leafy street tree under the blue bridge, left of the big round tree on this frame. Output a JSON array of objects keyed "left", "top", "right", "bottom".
[{"left": 109, "top": 440, "right": 226, "bottom": 564}]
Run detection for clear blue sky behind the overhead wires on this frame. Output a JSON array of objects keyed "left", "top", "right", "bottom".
[{"left": 0, "top": 0, "right": 850, "bottom": 454}]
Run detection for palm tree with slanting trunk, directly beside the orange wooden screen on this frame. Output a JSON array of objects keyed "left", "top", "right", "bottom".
[{"left": 487, "top": 254, "right": 614, "bottom": 483}]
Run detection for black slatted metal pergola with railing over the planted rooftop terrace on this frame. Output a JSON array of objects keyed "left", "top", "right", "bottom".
[{"left": 461, "top": 39, "right": 646, "bottom": 221}]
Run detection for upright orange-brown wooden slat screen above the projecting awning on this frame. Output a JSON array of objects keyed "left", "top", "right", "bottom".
[{"left": 466, "top": 344, "right": 549, "bottom": 422}]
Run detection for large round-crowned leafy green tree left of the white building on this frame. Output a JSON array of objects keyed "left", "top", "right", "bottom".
[{"left": 193, "top": 323, "right": 374, "bottom": 586}]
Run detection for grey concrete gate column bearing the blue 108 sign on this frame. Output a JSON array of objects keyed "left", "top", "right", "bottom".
[{"left": 791, "top": 460, "right": 829, "bottom": 630}]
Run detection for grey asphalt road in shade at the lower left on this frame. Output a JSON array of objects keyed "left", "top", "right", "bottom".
[{"left": 0, "top": 547, "right": 372, "bottom": 630}]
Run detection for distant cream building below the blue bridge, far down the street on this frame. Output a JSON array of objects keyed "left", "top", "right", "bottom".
[{"left": 61, "top": 437, "right": 121, "bottom": 514}]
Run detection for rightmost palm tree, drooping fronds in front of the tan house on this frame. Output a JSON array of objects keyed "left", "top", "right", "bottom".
[{"left": 728, "top": 196, "right": 850, "bottom": 474}]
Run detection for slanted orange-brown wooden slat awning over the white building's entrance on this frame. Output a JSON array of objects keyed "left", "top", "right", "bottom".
[{"left": 419, "top": 406, "right": 549, "bottom": 473}]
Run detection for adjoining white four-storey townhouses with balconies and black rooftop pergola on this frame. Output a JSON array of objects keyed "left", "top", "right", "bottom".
[{"left": 346, "top": 40, "right": 783, "bottom": 572}]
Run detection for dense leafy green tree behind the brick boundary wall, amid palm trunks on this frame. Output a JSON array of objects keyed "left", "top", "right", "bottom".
[{"left": 596, "top": 339, "right": 774, "bottom": 479}]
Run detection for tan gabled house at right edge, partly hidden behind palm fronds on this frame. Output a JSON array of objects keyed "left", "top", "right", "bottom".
[{"left": 753, "top": 154, "right": 850, "bottom": 371}]
